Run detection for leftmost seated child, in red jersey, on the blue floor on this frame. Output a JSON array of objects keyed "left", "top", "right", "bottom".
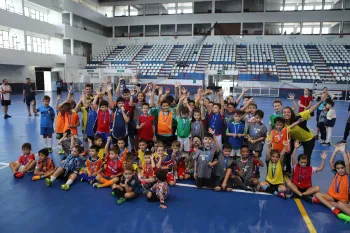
[{"left": 9, "top": 143, "right": 36, "bottom": 178}]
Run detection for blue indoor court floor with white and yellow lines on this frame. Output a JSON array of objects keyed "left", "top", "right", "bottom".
[{"left": 0, "top": 93, "right": 350, "bottom": 233}]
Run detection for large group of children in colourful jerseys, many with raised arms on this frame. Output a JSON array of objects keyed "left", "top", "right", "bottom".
[{"left": 10, "top": 78, "right": 350, "bottom": 220}]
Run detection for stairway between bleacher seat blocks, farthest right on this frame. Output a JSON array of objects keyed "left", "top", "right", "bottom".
[{"left": 305, "top": 45, "right": 334, "bottom": 81}]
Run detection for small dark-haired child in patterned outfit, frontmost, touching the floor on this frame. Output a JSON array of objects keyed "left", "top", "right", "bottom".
[{"left": 147, "top": 169, "right": 169, "bottom": 209}]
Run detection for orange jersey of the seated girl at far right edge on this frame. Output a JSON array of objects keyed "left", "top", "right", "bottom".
[{"left": 328, "top": 173, "right": 349, "bottom": 203}]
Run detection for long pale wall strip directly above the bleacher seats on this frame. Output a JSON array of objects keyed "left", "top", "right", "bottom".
[{"left": 109, "top": 35, "right": 350, "bottom": 44}]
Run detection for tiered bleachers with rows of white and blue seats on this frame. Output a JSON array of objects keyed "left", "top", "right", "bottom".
[{"left": 86, "top": 44, "right": 350, "bottom": 82}]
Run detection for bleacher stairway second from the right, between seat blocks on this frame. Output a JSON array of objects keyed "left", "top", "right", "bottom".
[{"left": 271, "top": 45, "right": 291, "bottom": 81}]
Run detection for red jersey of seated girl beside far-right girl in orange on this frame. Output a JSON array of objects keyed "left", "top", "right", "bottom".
[{"left": 292, "top": 164, "right": 317, "bottom": 189}]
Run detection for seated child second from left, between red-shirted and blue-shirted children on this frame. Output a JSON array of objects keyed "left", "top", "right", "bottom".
[{"left": 32, "top": 149, "right": 55, "bottom": 181}]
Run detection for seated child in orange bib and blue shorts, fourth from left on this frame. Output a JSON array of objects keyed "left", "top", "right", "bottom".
[{"left": 79, "top": 145, "right": 103, "bottom": 184}]
